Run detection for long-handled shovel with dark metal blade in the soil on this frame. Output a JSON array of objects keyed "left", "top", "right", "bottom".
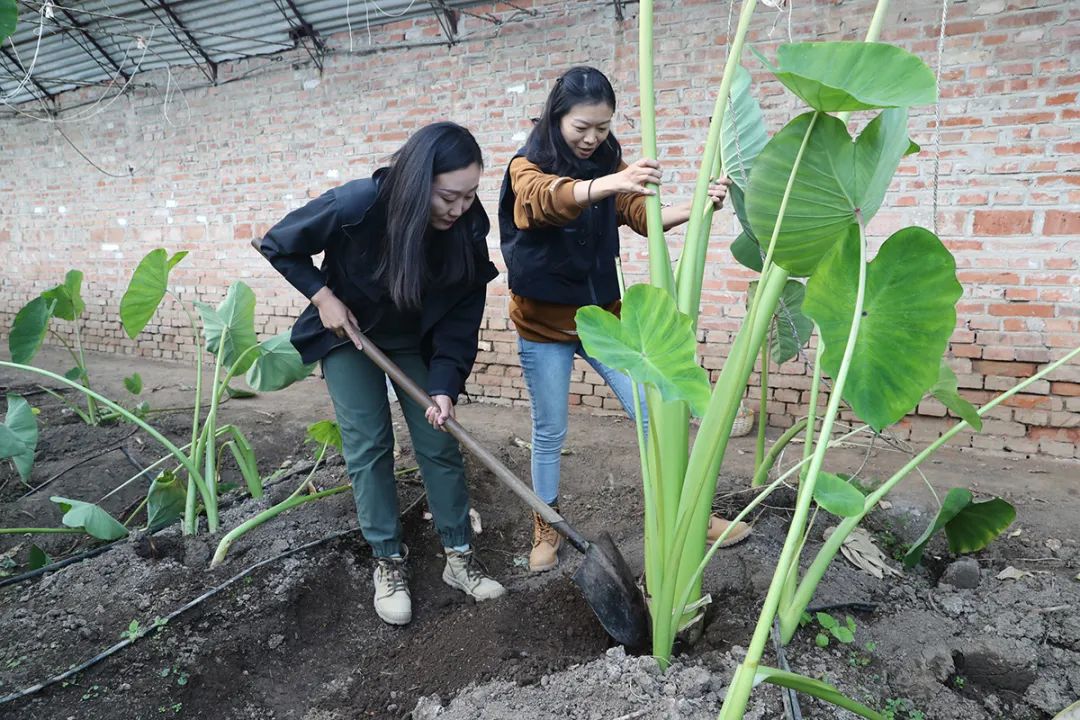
[{"left": 356, "top": 331, "right": 649, "bottom": 649}]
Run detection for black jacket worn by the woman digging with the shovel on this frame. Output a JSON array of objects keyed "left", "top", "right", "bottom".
[{"left": 259, "top": 172, "right": 499, "bottom": 399}]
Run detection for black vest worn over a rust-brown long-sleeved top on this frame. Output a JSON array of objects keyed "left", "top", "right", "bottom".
[{"left": 499, "top": 150, "right": 619, "bottom": 307}]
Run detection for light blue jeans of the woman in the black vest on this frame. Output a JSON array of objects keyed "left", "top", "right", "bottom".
[{"left": 517, "top": 338, "right": 648, "bottom": 504}]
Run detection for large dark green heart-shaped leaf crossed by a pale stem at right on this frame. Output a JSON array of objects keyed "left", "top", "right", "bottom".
[{"left": 802, "top": 227, "right": 963, "bottom": 431}]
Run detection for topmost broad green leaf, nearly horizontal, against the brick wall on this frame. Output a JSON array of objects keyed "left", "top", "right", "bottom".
[{"left": 754, "top": 42, "right": 937, "bottom": 112}]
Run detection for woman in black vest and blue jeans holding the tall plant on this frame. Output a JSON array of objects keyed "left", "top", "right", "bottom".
[{"left": 499, "top": 66, "right": 750, "bottom": 572}]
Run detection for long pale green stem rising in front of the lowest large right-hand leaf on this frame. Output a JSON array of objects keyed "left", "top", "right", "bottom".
[{"left": 720, "top": 220, "right": 866, "bottom": 720}]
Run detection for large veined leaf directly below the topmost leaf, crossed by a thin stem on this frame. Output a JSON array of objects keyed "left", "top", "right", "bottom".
[{"left": 746, "top": 108, "right": 910, "bottom": 276}]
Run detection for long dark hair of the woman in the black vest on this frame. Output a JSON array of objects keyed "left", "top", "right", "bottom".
[{"left": 525, "top": 65, "right": 622, "bottom": 178}]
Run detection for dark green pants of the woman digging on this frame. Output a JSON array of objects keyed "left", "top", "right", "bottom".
[{"left": 323, "top": 342, "right": 471, "bottom": 557}]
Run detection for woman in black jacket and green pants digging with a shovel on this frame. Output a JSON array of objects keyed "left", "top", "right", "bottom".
[{"left": 260, "top": 122, "right": 505, "bottom": 625}]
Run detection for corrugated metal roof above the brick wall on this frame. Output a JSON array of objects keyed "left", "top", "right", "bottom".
[{"left": 0, "top": 0, "right": 475, "bottom": 107}]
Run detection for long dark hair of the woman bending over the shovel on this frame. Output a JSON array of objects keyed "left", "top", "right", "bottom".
[{"left": 375, "top": 122, "right": 484, "bottom": 310}]
